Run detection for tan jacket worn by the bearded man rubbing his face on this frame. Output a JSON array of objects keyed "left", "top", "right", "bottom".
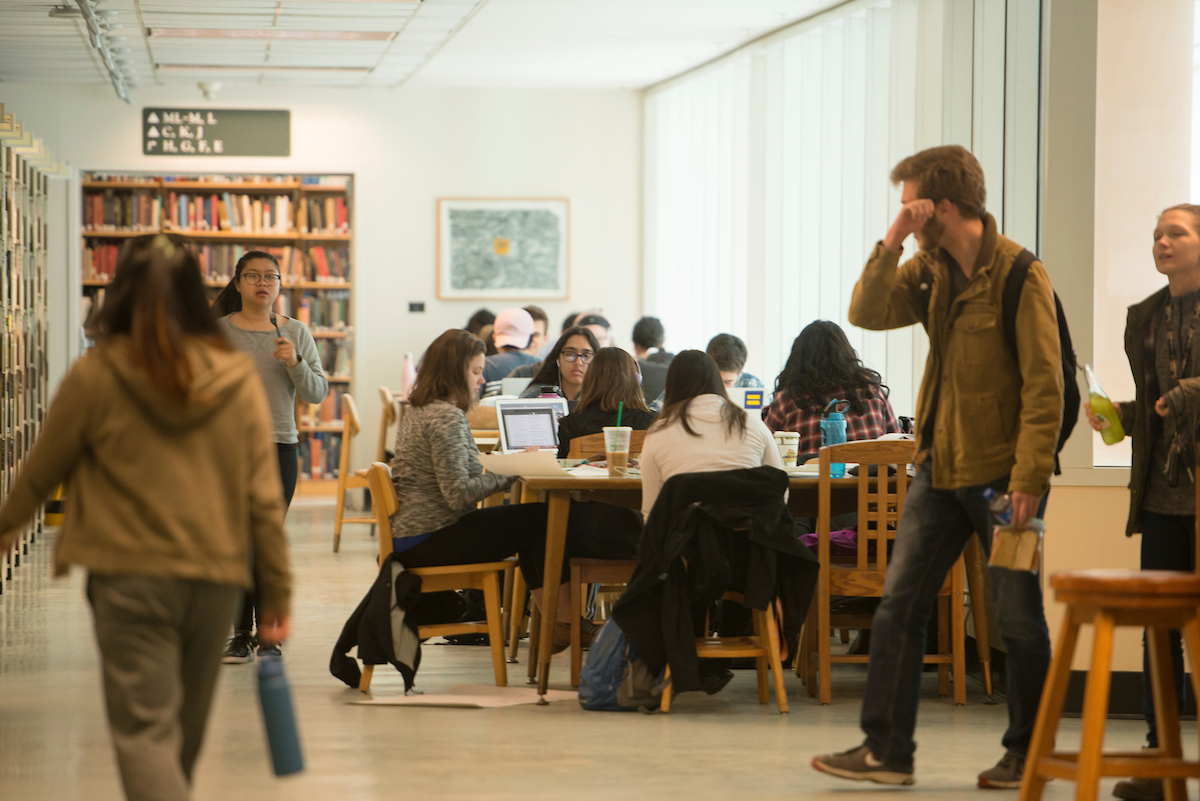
[{"left": 850, "top": 215, "right": 1062, "bottom": 495}]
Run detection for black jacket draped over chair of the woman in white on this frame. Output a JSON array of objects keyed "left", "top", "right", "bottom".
[{"left": 612, "top": 466, "right": 818, "bottom": 692}]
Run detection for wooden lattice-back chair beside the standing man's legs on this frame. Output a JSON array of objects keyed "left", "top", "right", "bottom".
[{"left": 796, "top": 440, "right": 967, "bottom": 704}]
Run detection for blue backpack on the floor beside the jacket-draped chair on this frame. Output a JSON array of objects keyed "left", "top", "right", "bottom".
[{"left": 580, "top": 620, "right": 665, "bottom": 712}]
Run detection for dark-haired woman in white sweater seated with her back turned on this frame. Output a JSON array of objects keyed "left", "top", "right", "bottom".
[{"left": 641, "top": 350, "right": 784, "bottom": 517}]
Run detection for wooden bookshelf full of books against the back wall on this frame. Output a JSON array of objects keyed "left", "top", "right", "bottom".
[{"left": 80, "top": 171, "right": 356, "bottom": 494}]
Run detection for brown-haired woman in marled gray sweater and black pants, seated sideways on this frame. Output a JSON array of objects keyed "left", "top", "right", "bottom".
[{"left": 391, "top": 329, "right": 641, "bottom": 651}]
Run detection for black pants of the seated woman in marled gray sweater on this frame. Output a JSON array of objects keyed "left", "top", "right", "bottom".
[{"left": 400, "top": 502, "right": 642, "bottom": 590}]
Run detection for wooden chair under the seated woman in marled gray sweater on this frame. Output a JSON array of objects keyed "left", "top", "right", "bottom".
[{"left": 359, "top": 462, "right": 515, "bottom": 692}]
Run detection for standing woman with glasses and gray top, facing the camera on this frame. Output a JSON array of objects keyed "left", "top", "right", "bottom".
[{"left": 212, "top": 251, "right": 329, "bottom": 664}]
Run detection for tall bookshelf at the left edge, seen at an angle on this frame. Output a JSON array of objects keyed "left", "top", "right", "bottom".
[{"left": 0, "top": 134, "right": 49, "bottom": 592}]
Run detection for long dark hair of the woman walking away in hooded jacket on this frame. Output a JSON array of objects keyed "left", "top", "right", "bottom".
[{"left": 96, "top": 234, "right": 230, "bottom": 403}]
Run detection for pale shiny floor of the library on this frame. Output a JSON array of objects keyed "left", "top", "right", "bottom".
[{"left": 0, "top": 499, "right": 1171, "bottom": 801}]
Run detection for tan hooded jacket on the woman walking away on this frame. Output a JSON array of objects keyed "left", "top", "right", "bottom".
[{"left": 0, "top": 338, "right": 290, "bottom": 615}]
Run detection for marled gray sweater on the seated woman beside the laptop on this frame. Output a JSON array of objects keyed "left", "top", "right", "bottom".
[{"left": 391, "top": 401, "right": 515, "bottom": 537}]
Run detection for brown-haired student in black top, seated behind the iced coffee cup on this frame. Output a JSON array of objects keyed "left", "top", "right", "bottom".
[{"left": 558, "top": 348, "right": 655, "bottom": 459}]
